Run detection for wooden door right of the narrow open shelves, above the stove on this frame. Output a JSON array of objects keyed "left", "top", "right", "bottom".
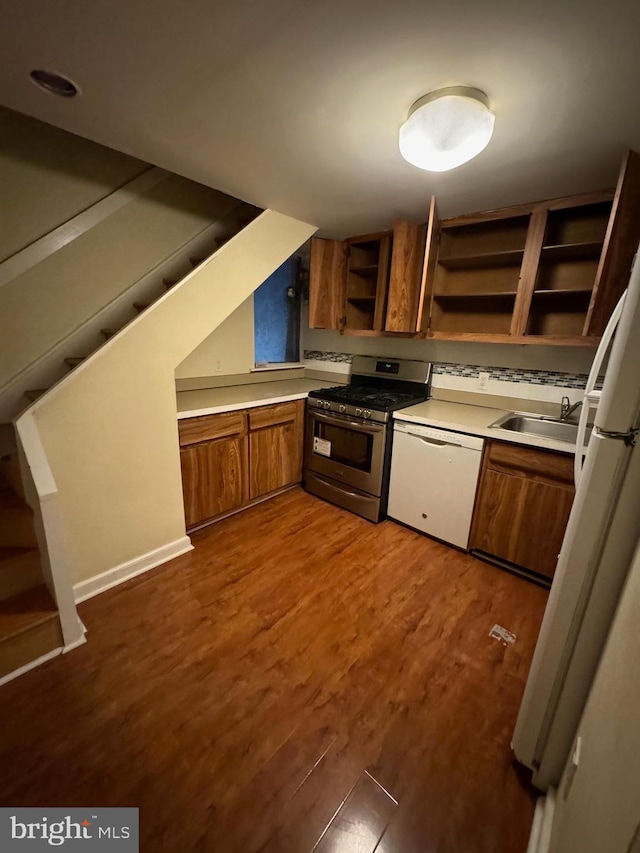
[{"left": 384, "top": 220, "right": 426, "bottom": 332}]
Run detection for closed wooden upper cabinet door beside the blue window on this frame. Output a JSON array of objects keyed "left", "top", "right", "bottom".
[{"left": 309, "top": 237, "right": 347, "bottom": 329}]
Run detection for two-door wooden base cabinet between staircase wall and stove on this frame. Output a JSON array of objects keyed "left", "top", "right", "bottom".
[{"left": 178, "top": 400, "right": 304, "bottom": 528}]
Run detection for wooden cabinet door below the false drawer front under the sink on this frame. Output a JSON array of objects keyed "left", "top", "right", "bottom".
[{"left": 471, "top": 469, "right": 573, "bottom": 577}]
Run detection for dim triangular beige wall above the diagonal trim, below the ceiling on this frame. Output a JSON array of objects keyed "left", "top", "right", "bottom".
[{"left": 0, "top": 107, "right": 149, "bottom": 262}]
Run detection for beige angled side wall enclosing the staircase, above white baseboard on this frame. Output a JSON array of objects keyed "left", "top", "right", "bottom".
[{"left": 31, "top": 211, "right": 315, "bottom": 583}]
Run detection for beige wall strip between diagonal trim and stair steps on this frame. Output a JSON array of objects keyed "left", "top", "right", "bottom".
[{"left": 0, "top": 175, "right": 237, "bottom": 387}]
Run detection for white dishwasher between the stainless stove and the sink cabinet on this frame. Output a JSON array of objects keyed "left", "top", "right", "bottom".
[{"left": 387, "top": 420, "right": 484, "bottom": 548}]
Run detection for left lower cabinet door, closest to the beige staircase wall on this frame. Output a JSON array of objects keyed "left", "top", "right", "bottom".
[{"left": 180, "top": 436, "right": 249, "bottom": 528}]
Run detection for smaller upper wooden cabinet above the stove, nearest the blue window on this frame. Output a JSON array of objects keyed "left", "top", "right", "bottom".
[{"left": 309, "top": 221, "right": 425, "bottom": 335}]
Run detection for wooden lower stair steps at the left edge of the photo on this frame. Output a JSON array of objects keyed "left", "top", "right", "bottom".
[{"left": 0, "top": 440, "right": 64, "bottom": 681}]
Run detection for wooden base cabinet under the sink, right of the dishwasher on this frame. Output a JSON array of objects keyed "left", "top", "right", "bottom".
[{"left": 469, "top": 441, "right": 574, "bottom": 578}]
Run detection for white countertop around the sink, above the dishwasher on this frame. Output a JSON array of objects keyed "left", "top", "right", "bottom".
[{"left": 393, "top": 400, "right": 575, "bottom": 454}]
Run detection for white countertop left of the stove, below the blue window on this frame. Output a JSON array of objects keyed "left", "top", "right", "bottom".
[{"left": 176, "top": 379, "right": 338, "bottom": 420}]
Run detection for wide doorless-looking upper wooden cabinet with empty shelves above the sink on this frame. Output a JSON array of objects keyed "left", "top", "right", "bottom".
[{"left": 420, "top": 152, "right": 640, "bottom": 346}]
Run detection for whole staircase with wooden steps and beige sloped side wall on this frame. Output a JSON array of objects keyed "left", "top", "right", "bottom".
[{"left": 5, "top": 202, "right": 315, "bottom": 684}]
